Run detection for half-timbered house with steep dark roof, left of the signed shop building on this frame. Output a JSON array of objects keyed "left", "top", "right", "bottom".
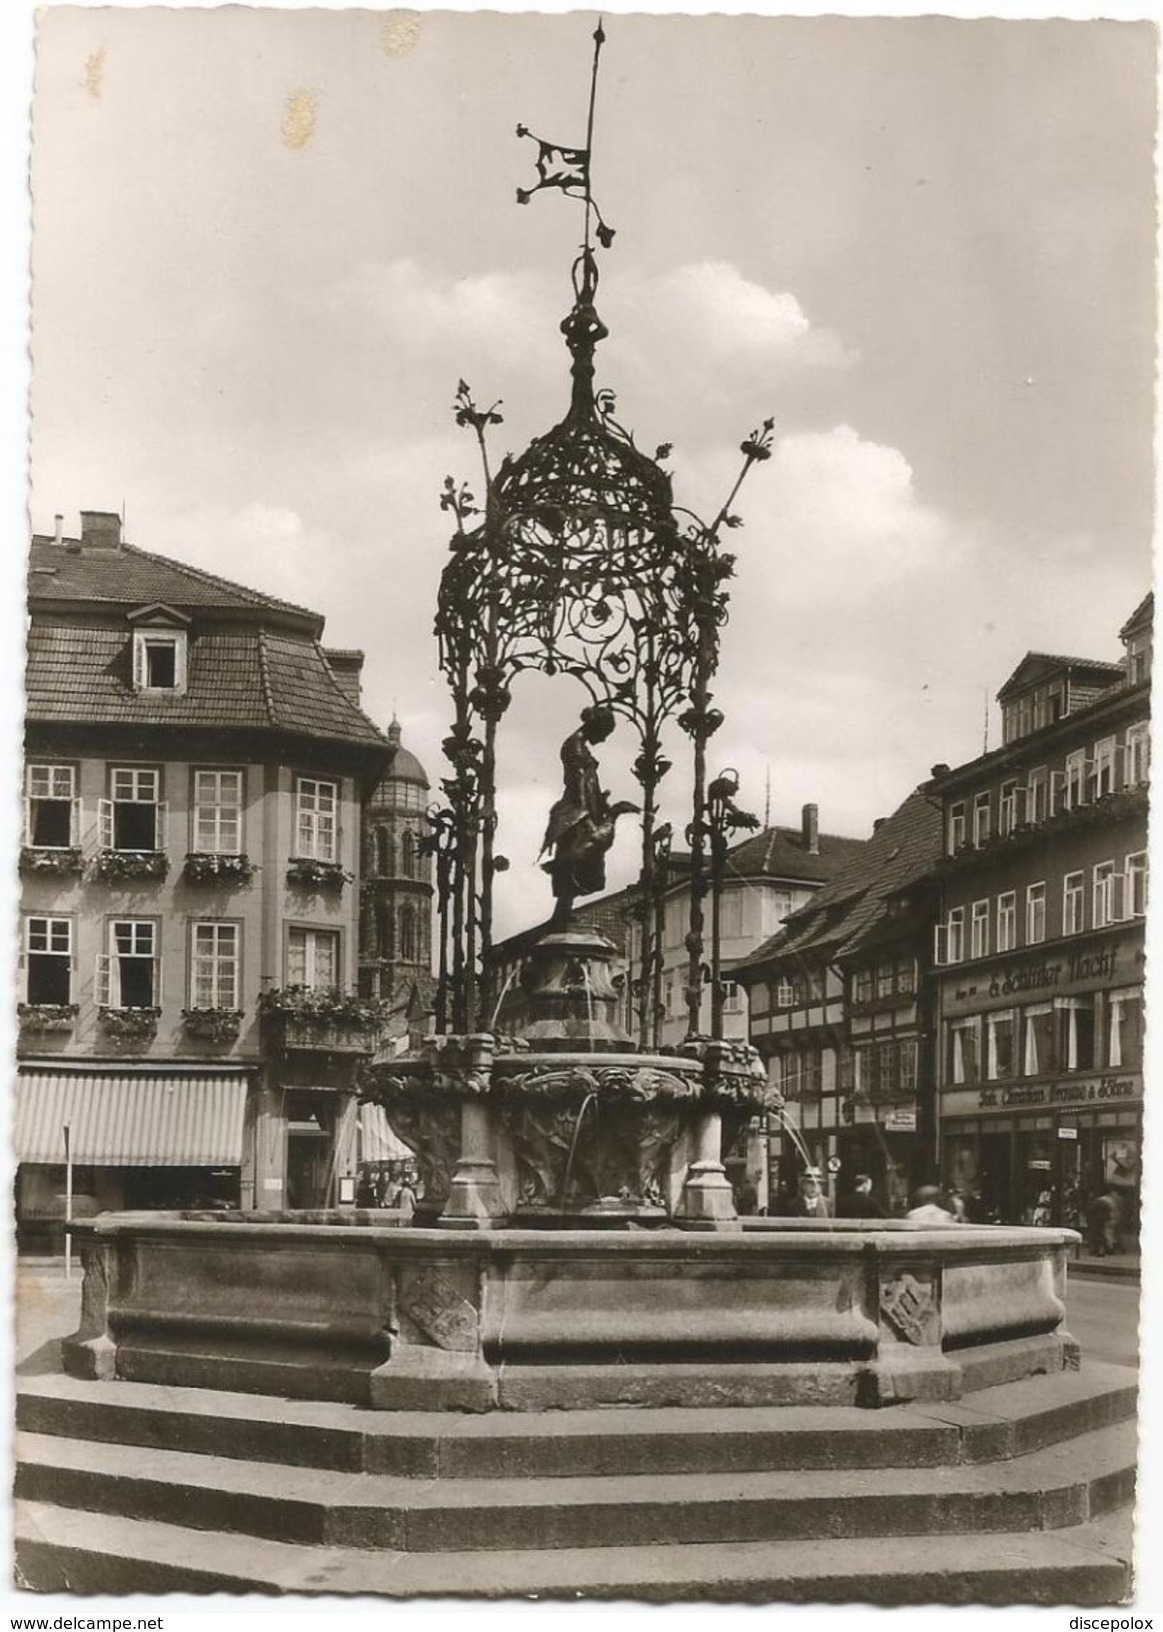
[{"left": 736, "top": 788, "right": 941, "bottom": 1213}]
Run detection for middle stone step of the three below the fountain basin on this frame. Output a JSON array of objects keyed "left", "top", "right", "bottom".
[{"left": 16, "top": 1423, "right": 1137, "bottom": 1552}]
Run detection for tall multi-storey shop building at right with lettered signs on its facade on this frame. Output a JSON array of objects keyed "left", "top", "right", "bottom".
[{"left": 931, "top": 596, "right": 1153, "bottom": 1237}]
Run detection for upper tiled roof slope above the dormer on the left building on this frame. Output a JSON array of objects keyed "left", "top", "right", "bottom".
[{"left": 28, "top": 534, "right": 323, "bottom": 633}]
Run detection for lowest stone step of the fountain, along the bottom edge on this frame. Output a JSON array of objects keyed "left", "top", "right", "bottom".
[{"left": 15, "top": 1501, "right": 1132, "bottom": 1608}]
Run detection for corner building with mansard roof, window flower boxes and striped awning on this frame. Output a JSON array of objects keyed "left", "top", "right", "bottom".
[{"left": 16, "top": 511, "right": 391, "bottom": 1239}]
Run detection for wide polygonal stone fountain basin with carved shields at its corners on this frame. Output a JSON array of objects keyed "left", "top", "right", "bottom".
[{"left": 64, "top": 1211, "right": 1078, "bottom": 1412}]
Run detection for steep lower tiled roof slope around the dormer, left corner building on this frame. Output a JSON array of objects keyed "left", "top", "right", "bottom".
[{"left": 26, "top": 622, "right": 387, "bottom": 747}]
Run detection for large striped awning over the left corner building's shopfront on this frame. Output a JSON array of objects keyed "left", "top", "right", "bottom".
[{"left": 16, "top": 1067, "right": 246, "bottom": 1167}]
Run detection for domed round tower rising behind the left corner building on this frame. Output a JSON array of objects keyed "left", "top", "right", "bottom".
[{"left": 359, "top": 720, "right": 434, "bottom": 1035}]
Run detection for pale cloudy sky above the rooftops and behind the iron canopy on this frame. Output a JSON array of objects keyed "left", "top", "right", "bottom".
[{"left": 18, "top": 7, "right": 1155, "bottom": 932}]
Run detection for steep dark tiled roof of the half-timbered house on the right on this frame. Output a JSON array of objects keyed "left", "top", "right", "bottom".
[{"left": 732, "top": 788, "right": 941, "bottom": 976}]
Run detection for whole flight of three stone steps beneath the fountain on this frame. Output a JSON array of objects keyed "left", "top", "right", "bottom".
[{"left": 16, "top": 1364, "right": 1137, "bottom": 1604}]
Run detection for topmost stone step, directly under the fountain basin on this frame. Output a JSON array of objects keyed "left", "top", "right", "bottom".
[{"left": 16, "top": 1364, "right": 1137, "bottom": 1479}]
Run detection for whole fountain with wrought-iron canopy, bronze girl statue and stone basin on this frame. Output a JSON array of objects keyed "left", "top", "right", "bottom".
[{"left": 65, "top": 26, "right": 1077, "bottom": 1412}]
